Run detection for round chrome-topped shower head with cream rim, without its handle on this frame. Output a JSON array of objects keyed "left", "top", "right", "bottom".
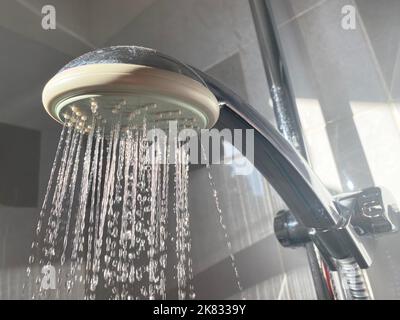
[{"left": 42, "top": 46, "right": 219, "bottom": 130}]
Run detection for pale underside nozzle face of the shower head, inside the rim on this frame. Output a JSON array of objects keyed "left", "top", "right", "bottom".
[{"left": 55, "top": 93, "right": 208, "bottom": 129}]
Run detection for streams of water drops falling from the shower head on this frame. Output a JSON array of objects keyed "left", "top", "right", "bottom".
[{"left": 27, "top": 104, "right": 195, "bottom": 299}]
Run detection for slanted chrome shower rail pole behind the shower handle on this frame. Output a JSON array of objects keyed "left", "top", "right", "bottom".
[{"left": 249, "top": 0, "right": 334, "bottom": 299}]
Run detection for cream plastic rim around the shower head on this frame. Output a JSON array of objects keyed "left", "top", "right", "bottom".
[{"left": 42, "top": 63, "right": 219, "bottom": 128}]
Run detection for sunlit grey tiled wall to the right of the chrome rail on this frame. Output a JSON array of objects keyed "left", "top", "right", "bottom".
[{"left": 271, "top": 0, "right": 400, "bottom": 298}]
